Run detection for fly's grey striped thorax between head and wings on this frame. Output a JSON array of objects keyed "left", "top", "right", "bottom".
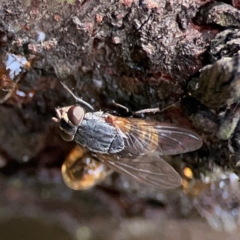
[{"left": 75, "top": 113, "right": 124, "bottom": 153}]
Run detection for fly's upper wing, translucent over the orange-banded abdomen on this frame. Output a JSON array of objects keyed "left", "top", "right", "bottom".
[{"left": 107, "top": 115, "right": 202, "bottom": 158}]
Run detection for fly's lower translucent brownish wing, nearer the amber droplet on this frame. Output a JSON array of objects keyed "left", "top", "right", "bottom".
[{"left": 94, "top": 154, "right": 182, "bottom": 189}]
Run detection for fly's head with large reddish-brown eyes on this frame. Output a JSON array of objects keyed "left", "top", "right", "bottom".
[{"left": 52, "top": 105, "right": 85, "bottom": 142}]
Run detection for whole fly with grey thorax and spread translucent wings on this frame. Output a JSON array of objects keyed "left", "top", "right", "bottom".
[{"left": 53, "top": 84, "right": 202, "bottom": 189}]
